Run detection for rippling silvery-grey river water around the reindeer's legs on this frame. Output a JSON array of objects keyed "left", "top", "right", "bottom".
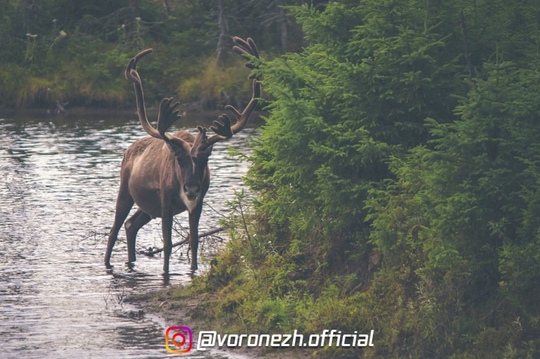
[{"left": 0, "top": 112, "right": 256, "bottom": 358}]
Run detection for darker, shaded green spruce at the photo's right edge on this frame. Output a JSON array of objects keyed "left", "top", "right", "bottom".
[{"left": 362, "top": 63, "right": 540, "bottom": 357}]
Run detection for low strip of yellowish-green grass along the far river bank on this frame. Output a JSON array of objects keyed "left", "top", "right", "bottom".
[{"left": 0, "top": 49, "right": 250, "bottom": 110}]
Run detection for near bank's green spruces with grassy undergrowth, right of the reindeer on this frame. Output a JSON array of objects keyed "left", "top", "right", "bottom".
[{"left": 188, "top": 0, "right": 540, "bottom": 358}]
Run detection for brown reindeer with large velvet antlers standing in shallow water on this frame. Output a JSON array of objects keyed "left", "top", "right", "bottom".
[{"left": 105, "top": 37, "right": 261, "bottom": 275}]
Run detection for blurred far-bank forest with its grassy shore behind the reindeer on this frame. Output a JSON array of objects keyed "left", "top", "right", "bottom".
[{"left": 0, "top": 0, "right": 324, "bottom": 108}]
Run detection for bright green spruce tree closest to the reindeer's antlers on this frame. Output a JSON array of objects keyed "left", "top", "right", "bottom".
[{"left": 248, "top": 2, "right": 463, "bottom": 276}]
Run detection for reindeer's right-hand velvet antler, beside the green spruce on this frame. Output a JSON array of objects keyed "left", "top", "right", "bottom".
[{"left": 203, "top": 36, "right": 261, "bottom": 148}]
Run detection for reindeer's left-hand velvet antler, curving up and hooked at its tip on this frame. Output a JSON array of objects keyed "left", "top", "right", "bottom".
[{"left": 125, "top": 49, "right": 182, "bottom": 145}]
